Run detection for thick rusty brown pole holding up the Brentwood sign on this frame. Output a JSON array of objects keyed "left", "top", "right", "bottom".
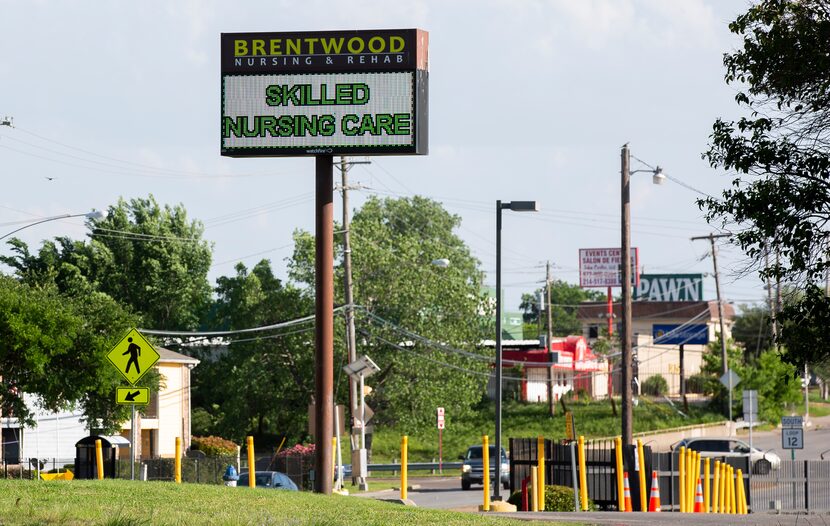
[{"left": 314, "top": 155, "right": 334, "bottom": 495}]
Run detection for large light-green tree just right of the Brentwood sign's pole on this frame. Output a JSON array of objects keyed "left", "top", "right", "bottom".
[{"left": 290, "top": 197, "right": 492, "bottom": 428}]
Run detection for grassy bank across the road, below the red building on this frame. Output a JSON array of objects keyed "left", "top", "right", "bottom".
[{"left": 372, "top": 397, "right": 723, "bottom": 462}]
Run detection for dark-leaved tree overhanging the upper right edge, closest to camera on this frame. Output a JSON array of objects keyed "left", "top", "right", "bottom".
[{"left": 699, "top": 0, "right": 830, "bottom": 366}]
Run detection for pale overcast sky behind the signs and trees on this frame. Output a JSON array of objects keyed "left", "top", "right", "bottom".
[{"left": 0, "top": 0, "right": 765, "bottom": 322}]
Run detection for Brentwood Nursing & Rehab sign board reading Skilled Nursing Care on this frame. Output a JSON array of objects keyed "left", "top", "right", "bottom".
[{"left": 221, "top": 29, "right": 429, "bottom": 157}]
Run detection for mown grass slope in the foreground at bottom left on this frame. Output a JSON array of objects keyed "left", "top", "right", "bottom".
[{"left": 0, "top": 480, "right": 552, "bottom": 526}]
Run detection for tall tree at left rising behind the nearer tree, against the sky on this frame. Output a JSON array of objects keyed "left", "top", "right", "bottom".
[{"left": 0, "top": 195, "right": 211, "bottom": 330}]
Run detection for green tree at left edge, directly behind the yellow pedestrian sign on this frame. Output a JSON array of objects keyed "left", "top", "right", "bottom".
[{"left": 0, "top": 276, "right": 141, "bottom": 432}]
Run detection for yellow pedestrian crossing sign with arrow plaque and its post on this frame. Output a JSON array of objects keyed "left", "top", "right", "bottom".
[{"left": 107, "top": 329, "right": 160, "bottom": 480}]
